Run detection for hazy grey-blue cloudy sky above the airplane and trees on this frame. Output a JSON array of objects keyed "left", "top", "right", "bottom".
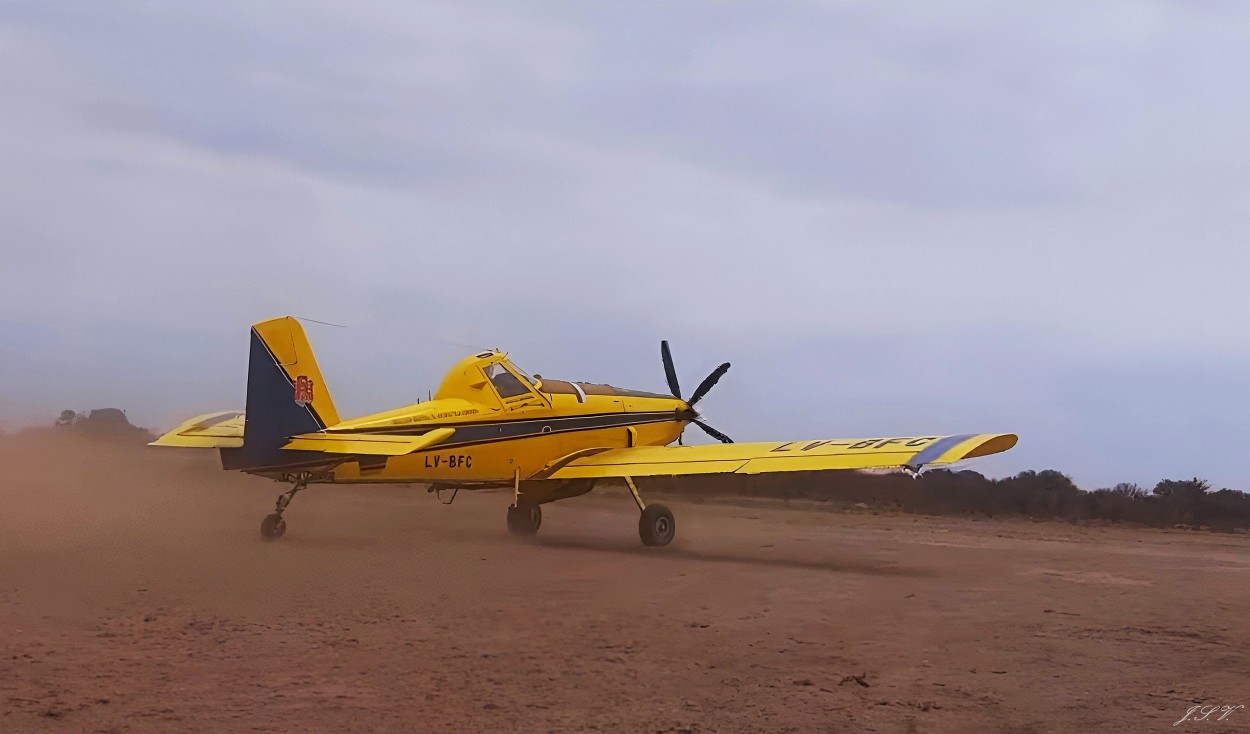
[{"left": 0, "top": 0, "right": 1250, "bottom": 489}]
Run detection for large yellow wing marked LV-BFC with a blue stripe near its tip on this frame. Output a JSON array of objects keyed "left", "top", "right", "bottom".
[{"left": 538, "top": 434, "right": 1016, "bottom": 479}]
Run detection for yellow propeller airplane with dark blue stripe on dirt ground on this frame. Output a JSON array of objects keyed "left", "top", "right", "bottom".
[{"left": 151, "top": 316, "right": 1016, "bottom": 545}]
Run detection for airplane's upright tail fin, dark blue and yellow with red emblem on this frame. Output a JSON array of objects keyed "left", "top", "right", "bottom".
[{"left": 221, "top": 316, "right": 339, "bottom": 469}]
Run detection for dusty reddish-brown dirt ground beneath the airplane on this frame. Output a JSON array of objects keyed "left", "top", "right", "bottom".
[{"left": 0, "top": 436, "right": 1250, "bottom": 734}]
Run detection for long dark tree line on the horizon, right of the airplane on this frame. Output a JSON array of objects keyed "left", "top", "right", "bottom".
[{"left": 651, "top": 469, "right": 1250, "bottom": 533}]
